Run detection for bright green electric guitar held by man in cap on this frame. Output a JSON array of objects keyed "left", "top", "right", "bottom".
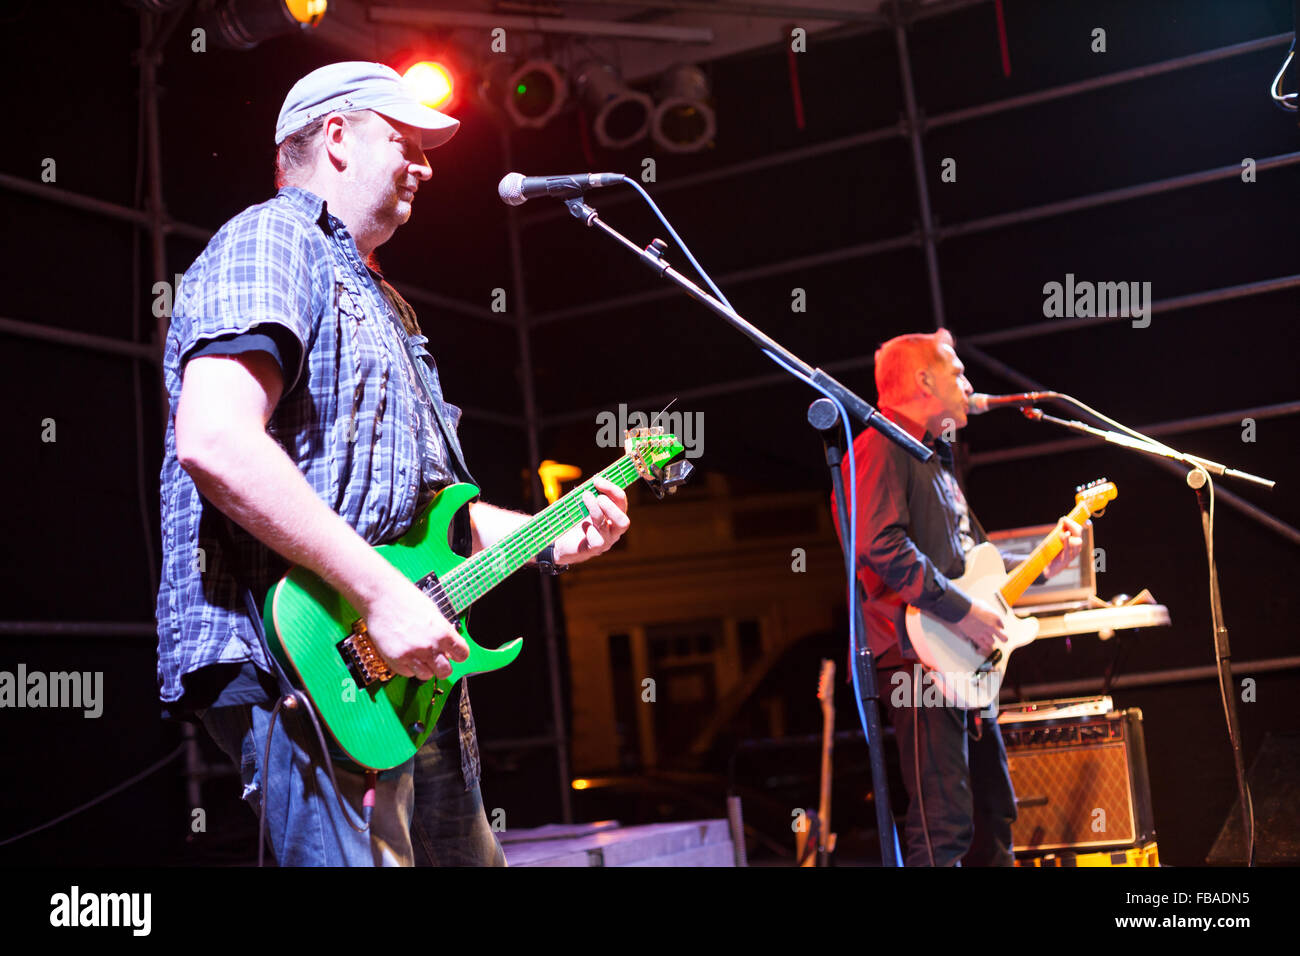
[{"left": 263, "top": 428, "right": 692, "bottom": 770}]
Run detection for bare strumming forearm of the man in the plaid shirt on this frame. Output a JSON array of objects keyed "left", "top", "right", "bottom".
[{"left": 181, "top": 429, "right": 406, "bottom": 610}]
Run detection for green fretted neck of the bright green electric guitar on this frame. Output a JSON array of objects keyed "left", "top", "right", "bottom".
[{"left": 439, "top": 455, "right": 637, "bottom": 614}]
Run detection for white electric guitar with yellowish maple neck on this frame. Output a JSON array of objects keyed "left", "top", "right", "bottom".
[{"left": 907, "top": 479, "right": 1119, "bottom": 709}]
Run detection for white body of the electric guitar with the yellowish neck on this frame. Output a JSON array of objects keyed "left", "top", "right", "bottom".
[{"left": 907, "top": 541, "right": 1039, "bottom": 710}]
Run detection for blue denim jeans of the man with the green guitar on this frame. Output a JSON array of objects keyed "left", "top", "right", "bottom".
[{"left": 202, "top": 704, "right": 506, "bottom": 866}]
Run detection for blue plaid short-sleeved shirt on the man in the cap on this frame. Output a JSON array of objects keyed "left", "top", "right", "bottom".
[{"left": 157, "top": 187, "right": 472, "bottom": 780}]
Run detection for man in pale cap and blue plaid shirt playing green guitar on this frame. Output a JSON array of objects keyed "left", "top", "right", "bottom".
[{"left": 157, "top": 62, "right": 629, "bottom": 865}]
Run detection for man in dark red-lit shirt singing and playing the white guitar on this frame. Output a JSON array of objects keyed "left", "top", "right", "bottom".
[{"left": 836, "top": 329, "right": 1083, "bottom": 866}]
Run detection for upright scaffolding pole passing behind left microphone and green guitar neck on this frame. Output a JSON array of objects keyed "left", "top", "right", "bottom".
[{"left": 498, "top": 124, "right": 573, "bottom": 823}]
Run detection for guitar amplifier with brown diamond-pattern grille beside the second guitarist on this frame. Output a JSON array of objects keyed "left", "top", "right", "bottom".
[{"left": 998, "top": 697, "right": 1156, "bottom": 853}]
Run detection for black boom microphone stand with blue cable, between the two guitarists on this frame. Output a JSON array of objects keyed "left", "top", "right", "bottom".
[{"left": 564, "top": 196, "right": 935, "bottom": 866}]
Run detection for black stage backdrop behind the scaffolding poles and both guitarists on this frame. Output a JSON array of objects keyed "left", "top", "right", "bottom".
[{"left": 0, "top": 0, "right": 1300, "bottom": 865}]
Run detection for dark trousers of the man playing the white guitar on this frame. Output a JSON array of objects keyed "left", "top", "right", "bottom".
[{"left": 880, "top": 667, "right": 1017, "bottom": 866}]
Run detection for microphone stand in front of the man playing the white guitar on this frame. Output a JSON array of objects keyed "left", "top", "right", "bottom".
[{"left": 1021, "top": 395, "right": 1275, "bottom": 866}]
